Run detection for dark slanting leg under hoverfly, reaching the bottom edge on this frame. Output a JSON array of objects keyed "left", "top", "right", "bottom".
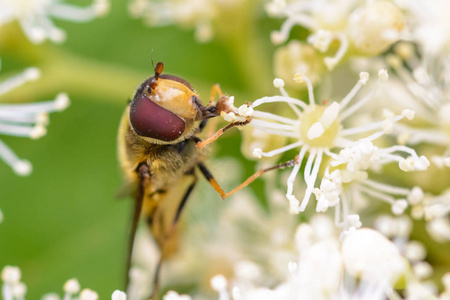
[{"left": 150, "top": 175, "right": 197, "bottom": 299}]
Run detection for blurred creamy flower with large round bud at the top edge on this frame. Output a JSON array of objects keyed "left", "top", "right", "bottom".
[{"left": 266, "top": 0, "right": 404, "bottom": 70}]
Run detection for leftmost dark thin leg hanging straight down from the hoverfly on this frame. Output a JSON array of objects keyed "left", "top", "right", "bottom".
[{"left": 125, "top": 163, "right": 150, "bottom": 288}]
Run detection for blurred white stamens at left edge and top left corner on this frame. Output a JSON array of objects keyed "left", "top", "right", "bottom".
[{"left": 0, "top": 0, "right": 97, "bottom": 180}]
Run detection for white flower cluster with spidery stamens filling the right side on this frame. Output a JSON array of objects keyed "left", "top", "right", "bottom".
[{"left": 152, "top": 0, "right": 450, "bottom": 300}]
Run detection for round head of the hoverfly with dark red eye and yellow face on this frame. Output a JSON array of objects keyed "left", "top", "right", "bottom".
[{"left": 129, "top": 74, "right": 202, "bottom": 144}]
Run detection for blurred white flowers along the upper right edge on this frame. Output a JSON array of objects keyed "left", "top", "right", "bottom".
[{"left": 386, "top": 26, "right": 450, "bottom": 168}]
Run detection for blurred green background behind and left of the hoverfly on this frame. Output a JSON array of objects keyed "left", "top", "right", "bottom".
[{"left": 0, "top": 0, "right": 275, "bottom": 299}]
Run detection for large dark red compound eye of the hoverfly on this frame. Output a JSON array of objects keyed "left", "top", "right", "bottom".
[{"left": 130, "top": 95, "right": 185, "bottom": 142}]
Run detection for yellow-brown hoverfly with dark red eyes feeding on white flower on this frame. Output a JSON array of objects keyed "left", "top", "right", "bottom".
[{"left": 118, "top": 62, "right": 294, "bottom": 299}]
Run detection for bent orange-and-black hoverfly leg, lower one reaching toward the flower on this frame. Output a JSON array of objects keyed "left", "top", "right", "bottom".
[{"left": 198, "top": 156, "right": 298, "bottom": 199}]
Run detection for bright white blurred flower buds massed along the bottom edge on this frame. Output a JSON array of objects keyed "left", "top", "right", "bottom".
[{"left": 164, "top": 216, "right": 450, "bottom": 300}]
